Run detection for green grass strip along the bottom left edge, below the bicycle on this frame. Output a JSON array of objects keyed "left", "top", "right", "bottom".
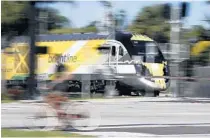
[{"left": 1, "top": 129, "right": 92, "bottom": 138}]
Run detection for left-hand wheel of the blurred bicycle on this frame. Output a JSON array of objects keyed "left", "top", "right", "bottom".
[{"left": 24, "top": 105, "right": 59, "bottom": 130}]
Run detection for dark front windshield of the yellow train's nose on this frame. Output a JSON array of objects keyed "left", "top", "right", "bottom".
[{"left": 132, "top": 41, "right": 164, "bottom": 63}]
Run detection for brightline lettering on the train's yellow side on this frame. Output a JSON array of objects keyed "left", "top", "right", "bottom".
[{"left": 48, "top": 54, "right": 77, "bottom": 63}]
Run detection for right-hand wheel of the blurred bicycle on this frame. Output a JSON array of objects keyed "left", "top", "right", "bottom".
[{"left": 65, "top": 102, "right": 101, "bottom": 131}]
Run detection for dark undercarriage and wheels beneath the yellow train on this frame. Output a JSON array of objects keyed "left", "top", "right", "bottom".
[{"left": 7, "top": 80, "right": 160, "bottom": 96}]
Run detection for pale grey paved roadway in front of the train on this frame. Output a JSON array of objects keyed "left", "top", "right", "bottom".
[{"left": 2, "top": 97, "right": 210, "bottom": 137}]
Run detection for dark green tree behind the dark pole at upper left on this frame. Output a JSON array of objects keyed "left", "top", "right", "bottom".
[{"left": 2, "top": 1, "right": 69, "bottom": 38}]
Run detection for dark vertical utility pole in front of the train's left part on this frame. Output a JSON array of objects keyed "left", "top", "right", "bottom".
[{"left": 27, "top": 1, "right": 36, "bottom": 99}]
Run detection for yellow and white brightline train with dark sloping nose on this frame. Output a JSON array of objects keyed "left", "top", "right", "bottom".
[{"left": 2, "top": 32, "right": 170, "bottom": 96}]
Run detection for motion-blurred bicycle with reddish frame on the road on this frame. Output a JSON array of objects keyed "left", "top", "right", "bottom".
[{"left": 24, "top": 85, "right": 101, "bottom": 131}]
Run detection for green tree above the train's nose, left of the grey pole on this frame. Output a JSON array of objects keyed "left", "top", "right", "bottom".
[{"left": 128, "top": 5, "right": 170, "bottom": 41}]
